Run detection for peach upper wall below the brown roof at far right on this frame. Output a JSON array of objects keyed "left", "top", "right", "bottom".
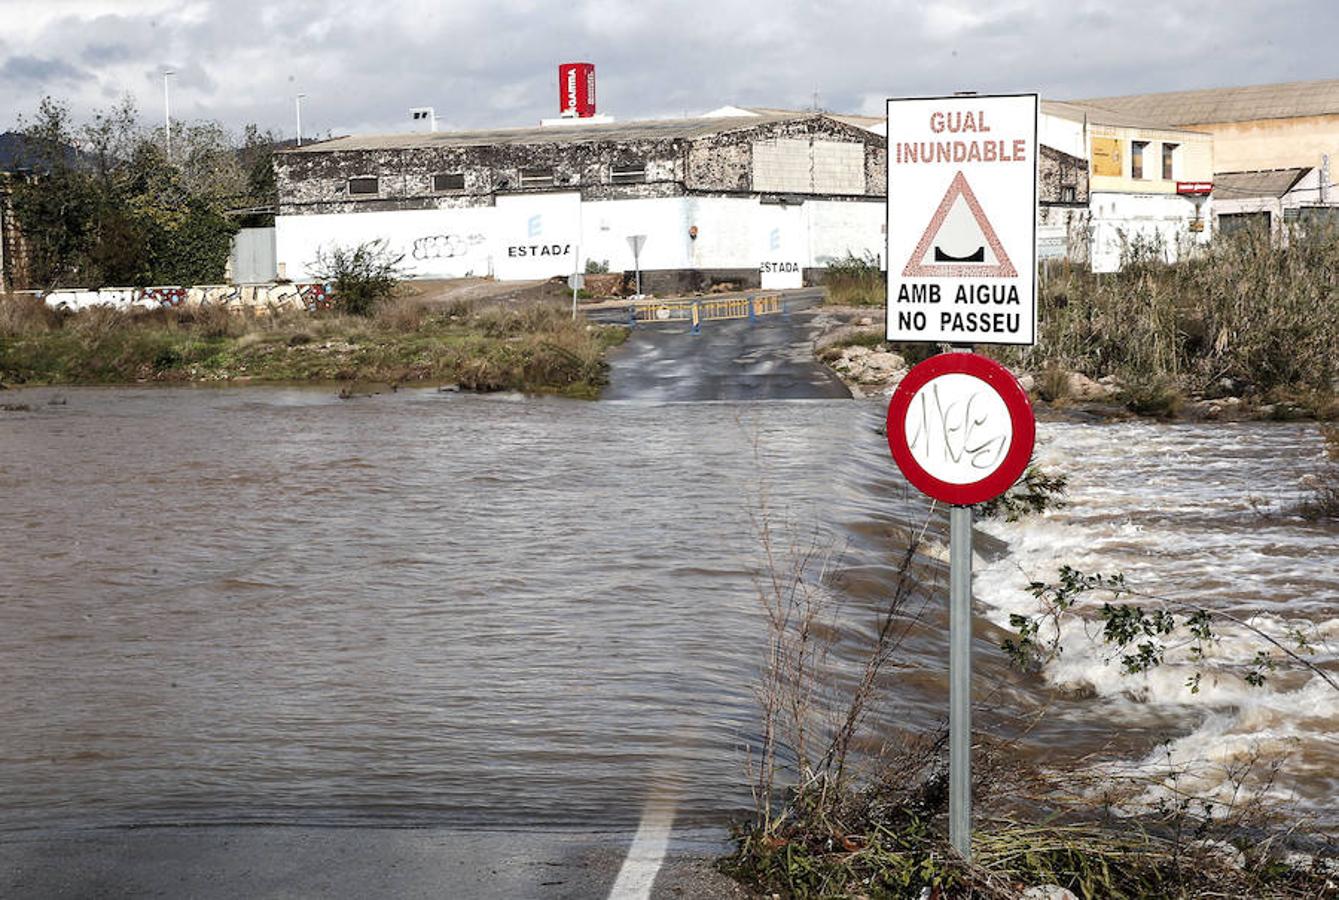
[{"left": 1185, "top": 115, "right": 1339, "bottom": 171}]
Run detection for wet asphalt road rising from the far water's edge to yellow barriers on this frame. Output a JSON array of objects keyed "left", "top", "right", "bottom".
[{"left": 603, "top": 291, "right": 850, "bottom": 402}]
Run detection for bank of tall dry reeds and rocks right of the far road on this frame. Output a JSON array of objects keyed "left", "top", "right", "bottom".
[{"left": 819, "top": 228, "right": 1339, "bottom": 419}]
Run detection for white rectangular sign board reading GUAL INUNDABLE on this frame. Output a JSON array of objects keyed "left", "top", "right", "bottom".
[{"left": 886, "top": 94, "right": 1038, "bottom": 344}]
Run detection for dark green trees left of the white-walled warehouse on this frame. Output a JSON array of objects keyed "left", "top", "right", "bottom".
[{"left": 9, "top": 96, "right": 277, "bottom": 289}]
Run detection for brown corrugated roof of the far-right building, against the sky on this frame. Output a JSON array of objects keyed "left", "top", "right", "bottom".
[{"left": 1077, "top": 79, "right": 1339, "bottom": 125}]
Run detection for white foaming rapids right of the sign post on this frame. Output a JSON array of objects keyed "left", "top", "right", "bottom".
[{"left": 976, "top": 425, "right": 1339, "bottom": 817}]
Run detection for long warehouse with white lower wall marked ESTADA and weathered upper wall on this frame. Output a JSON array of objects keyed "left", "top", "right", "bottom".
[{"left": 274, "top": 114, "right": 886, "bottom": 292}]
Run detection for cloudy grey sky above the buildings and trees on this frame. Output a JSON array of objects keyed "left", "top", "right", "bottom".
[{"left": 0, "top": 0, "right": 1339, "bottom": 135}]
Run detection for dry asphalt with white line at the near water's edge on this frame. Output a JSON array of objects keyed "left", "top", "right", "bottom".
[{"left": 0, "top": 825, "right": 749, "bottom": 900}]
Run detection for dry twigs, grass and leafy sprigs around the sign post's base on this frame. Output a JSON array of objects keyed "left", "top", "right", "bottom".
[{"left": 720, "top": 498, "right": 1339, "bottom": 900}]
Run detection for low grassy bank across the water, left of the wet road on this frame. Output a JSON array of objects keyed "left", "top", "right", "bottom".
[{"left": 0, "top": 296, "right": 625, "bottom": 398}]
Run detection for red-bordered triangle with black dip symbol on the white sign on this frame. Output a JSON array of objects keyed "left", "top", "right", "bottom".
[{"left": 902, "top": 171, "right": 1018, "bottom": 279}]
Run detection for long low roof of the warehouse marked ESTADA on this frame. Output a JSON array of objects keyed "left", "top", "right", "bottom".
[{"left": 284, "top": 113, "right": 814, "bottom": 153}]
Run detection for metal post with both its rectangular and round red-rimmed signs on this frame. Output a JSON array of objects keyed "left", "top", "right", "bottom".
[{"left": 885, "top": 94, "right": 1040, "bottom": 860}]
